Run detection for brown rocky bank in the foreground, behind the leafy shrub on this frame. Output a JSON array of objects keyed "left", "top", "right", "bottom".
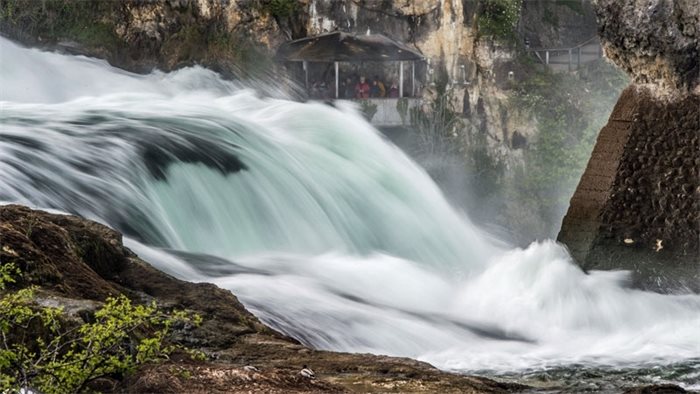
[{"left": 0, "top": 205, "right": 523, "bottom": 393}]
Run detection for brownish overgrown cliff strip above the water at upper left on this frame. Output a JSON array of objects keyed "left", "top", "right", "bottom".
[{"left": 0, "top": 0, "right": 276, "bottom": 77}]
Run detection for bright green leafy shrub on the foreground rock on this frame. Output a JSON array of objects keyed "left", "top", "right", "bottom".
[{"left": 0, "top": 264, "right": 201, "bottom": 394}]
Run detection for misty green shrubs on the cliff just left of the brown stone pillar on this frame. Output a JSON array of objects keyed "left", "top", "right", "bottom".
[{"left": 508, "top": 60, "right": 627, "bottom": 236}]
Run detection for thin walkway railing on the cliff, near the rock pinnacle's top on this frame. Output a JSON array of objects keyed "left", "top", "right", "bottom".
[{"left": 528, "top": 37, "right": 603, "bottom": 71}]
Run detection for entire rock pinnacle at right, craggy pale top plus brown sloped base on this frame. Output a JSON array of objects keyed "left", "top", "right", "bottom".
[{"left": 559, "top": 0, "right": 700, "bottom": 292}]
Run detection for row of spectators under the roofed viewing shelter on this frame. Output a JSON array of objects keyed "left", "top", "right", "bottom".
[{"left": 309, "top": 75, "right": 399, "bottom": 99}]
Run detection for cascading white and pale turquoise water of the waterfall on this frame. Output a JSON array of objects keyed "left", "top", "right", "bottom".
[{"left": 0, "top": 39, "right": 700, "bottom": 390}]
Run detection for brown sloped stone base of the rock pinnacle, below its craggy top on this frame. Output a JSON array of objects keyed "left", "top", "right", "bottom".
[{"left": 559, "top": 85, "right": 700, "bottom": 291}]
